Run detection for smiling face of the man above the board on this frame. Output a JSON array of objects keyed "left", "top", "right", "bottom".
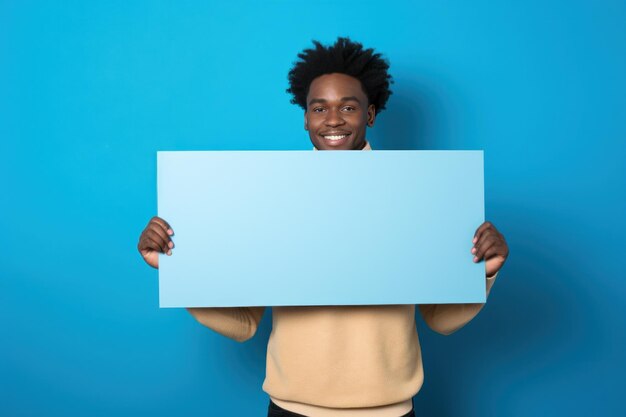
[{"left": 304, "top": 74, "right": 376, "bottom": 150}]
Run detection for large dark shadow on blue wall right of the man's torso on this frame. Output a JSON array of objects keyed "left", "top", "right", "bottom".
[{"left": 415, "top": 207, "right": 593, "bottom": 416}]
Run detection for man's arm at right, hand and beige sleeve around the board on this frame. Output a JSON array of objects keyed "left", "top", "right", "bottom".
[{"left": 419, "top": 222, "right": 509, "bottom": 335}]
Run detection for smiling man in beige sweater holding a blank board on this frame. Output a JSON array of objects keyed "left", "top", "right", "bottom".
[{"left": 138, "top": 38, "right": 508, "bottom": 417}]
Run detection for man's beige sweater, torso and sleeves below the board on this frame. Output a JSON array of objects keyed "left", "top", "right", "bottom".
[{"left": 183, "top": 142, "right": 495, "bottom": 417}]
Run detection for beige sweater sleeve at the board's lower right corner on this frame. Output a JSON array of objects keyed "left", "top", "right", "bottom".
[{"left": 419, "top": 272, "right": 498, "bottom": 335}]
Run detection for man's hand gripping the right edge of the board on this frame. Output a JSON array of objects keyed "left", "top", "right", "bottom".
[{"left": 471, "top": 222, "right": 509, "bottom": 277}]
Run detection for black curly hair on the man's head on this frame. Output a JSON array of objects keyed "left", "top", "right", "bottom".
[{"left": 287, "top": 37, "right": 393, "bottom": 114}]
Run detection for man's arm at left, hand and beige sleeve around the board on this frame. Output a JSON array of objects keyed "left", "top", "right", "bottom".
[{"left": 137, "top": 216, "right": 265, "bottom": 342}]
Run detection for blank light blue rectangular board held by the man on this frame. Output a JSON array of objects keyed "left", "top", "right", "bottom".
[{"left": 157, "top": 151, "right": 485, "bottom": 307}]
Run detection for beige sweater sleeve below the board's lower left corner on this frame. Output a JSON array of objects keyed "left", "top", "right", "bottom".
[{"left": 187, "top": 307, "right": 265, "bottom": 342}]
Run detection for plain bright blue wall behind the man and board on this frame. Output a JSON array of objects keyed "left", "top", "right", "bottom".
[{"left": 0, "top": 0, "right": 626, "bottom": 416}]
